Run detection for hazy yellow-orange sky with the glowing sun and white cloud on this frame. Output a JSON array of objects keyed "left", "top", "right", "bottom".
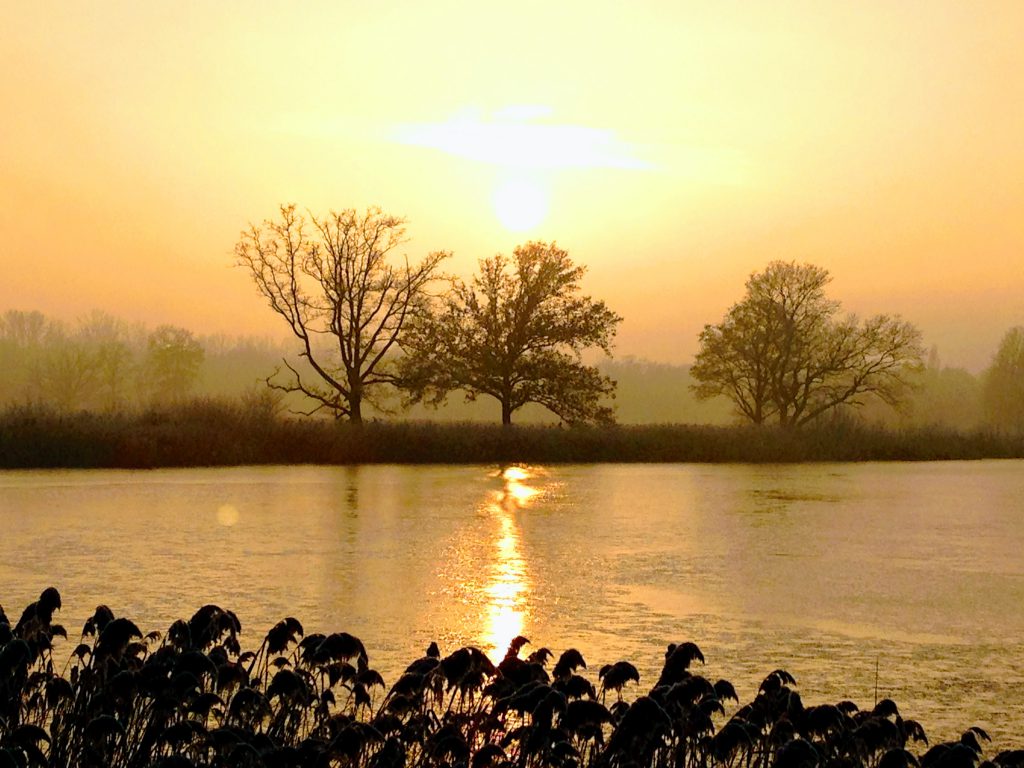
[{"left": 0, "top": 0, "right": 1024, "bottom": 370}]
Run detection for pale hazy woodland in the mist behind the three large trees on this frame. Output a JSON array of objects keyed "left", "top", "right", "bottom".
[{"left": 0, "top": 310, "right": 1008, "bottom": 432}]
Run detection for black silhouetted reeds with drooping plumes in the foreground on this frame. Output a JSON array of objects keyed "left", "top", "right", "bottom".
[{"left": 0, "top": 588, "right": 1024, "bottom": 768}]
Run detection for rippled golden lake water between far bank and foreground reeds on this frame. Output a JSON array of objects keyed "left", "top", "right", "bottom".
[{"left": 0, "top": 461, "right": 1024, "bottom": 749}]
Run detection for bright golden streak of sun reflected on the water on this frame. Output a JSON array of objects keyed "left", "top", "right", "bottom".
[{"left": 482, "top": 467, "right": 541, "bottom": 660}]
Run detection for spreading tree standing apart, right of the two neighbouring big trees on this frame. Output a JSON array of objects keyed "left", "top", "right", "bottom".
[{"left": 690, "top": 261, "right": 923, "bottom": 427}]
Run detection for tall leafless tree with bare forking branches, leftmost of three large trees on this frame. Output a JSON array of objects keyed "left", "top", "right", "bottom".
[{"left": 234, "top": 205, "right": 449, "bottom": 423}]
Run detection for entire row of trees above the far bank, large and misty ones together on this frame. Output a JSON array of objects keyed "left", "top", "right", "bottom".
[{"left": 0, "top": 206, "right": 1024, "bottom": 431}]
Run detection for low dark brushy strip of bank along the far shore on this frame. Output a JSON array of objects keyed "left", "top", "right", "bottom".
[{"left": 0, "top": 400, "right": 1024, "bottom": 469}]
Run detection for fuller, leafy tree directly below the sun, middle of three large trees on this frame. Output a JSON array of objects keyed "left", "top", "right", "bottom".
[{"left": 401, "top": 243, "right": 622, "bottom": 424}]
